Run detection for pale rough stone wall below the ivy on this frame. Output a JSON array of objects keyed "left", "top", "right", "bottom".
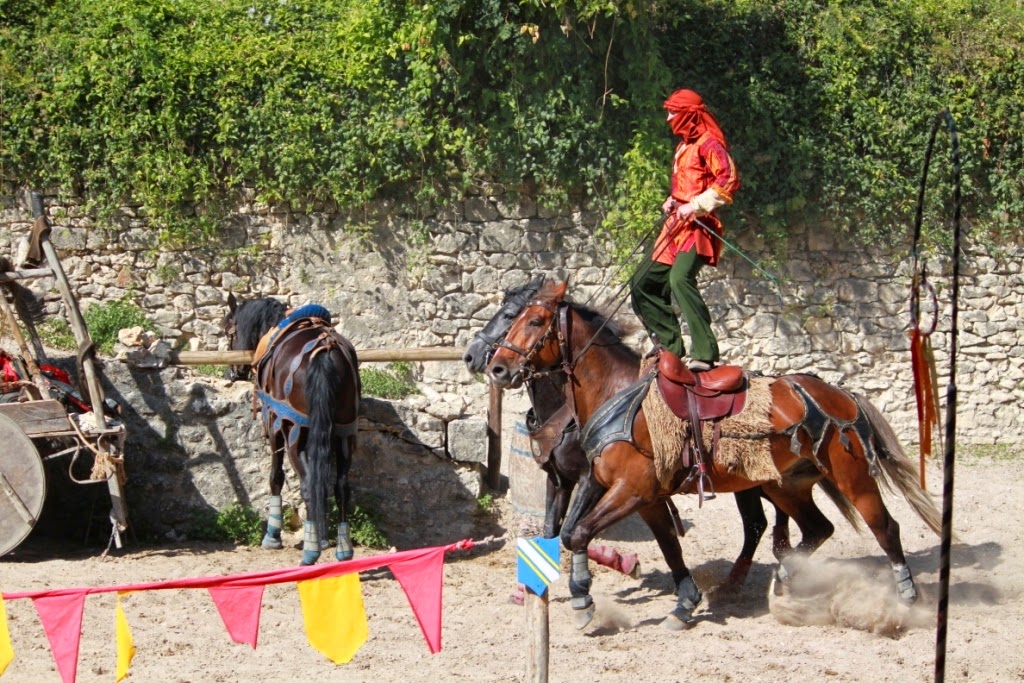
[{"left": 0, "top": 187, "right": 1024, "bottom": 540}]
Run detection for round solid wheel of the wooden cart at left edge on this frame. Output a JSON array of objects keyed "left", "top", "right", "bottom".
[{"left": 0, "top": 415, "right": 46, "bottom": 555}]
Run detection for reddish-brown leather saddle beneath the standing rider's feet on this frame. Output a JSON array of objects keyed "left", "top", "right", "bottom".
[{"left": 657, "top": 349, "right": 746, "bottom": 424}]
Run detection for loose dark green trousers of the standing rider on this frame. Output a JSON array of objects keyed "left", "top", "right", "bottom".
[{"left": 630, "top": 247, "right": 720, "bottom": 362}]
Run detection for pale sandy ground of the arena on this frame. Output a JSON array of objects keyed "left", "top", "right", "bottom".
[{"left": 0, "top": 459, "right": 1024, "bottom": 683}]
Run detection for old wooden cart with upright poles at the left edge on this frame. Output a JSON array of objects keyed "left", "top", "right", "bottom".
[{"left": 0, "top": 193, "right": 128, "bottom": 555}]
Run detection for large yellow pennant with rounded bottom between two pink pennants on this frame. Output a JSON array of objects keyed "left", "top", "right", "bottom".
[{"left": 297, "top": 571, "right": 370, "bottom": 664}]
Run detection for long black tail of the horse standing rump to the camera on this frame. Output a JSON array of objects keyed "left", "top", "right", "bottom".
[{"left": 305, "top": 350, "right": 341, "bottom": 544}]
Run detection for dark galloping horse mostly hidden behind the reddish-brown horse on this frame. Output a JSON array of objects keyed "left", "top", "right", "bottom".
[{"left": 463, "top": 276, "right": 856, "bottom": 588}]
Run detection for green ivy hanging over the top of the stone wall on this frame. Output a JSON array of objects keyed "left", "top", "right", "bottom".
[{"left": 0, "top": 0, "right": 1024, "bottom": 253}]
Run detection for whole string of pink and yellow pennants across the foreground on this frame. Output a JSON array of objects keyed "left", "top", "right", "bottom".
[{"left": 0, "top": 539, "right": 474, "bottom": 683}]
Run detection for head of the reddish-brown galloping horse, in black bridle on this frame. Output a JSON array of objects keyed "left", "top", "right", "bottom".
[{"left": 486, "top": 282, "right": 568, "bottom": 388}]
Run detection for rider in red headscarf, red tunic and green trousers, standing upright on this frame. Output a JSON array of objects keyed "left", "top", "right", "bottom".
[{"left": 630, "top": 89, "right": 739, "bottom": 371}]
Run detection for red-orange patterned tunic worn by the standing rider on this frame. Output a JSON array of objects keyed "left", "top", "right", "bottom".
[{"left": 654, "top": 132, "right": 739, "bottom": 265}]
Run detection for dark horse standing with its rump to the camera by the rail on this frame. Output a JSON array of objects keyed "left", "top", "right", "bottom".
[{"left": 223, "top": 294, "right": 361, "bottom": 564}]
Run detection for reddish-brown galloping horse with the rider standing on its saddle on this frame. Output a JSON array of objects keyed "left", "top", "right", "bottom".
[{"left": 487, "top": 283, "right": 940, "bottom": 626}]
